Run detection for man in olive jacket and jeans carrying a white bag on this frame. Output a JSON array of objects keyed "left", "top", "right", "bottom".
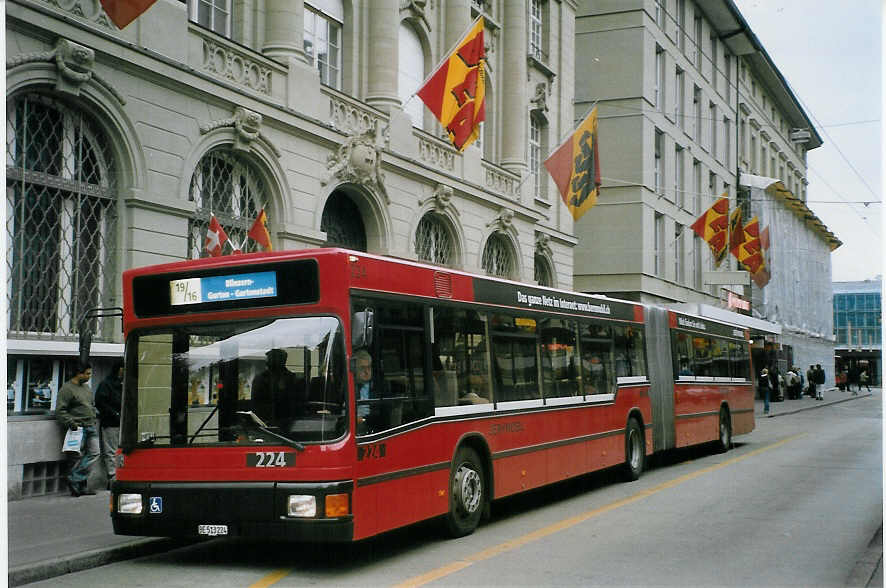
[{"left": 55, "top": 363, "right": 98, "bottom": 496}]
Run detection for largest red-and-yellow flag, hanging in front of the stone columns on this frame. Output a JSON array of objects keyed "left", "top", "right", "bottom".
[{"left": 417, "top": 16, "right": 486, "bottom": 151}]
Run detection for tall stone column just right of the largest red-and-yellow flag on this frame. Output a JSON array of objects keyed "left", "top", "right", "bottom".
[{"left": 496, "top": 2, "right": 529, "bottom": 176}]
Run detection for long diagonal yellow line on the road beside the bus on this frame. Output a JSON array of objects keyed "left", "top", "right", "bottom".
[{"left": 395, "top": 433, "right": 806, "bottom": 588}]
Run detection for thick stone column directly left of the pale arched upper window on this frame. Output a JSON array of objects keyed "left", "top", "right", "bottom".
[{"left": 366, "top": 0, "right": 400, "bottom": 112}]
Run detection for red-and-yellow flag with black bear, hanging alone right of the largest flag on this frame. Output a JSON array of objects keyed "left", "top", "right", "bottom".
[{"left": 545, "top": 106, "right": 600, "bottom": 220}]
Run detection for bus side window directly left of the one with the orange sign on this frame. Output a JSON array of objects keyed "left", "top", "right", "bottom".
[{"left": 431, "top": 307, "right": 491, "bottom": 407}]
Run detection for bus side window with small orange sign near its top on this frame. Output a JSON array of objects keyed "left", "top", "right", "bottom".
[{"left": 490, "top": 314, "right": 541, "bottom": 402}]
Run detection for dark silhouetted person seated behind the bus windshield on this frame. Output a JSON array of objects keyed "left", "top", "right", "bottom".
[{"left": 252, "top": 349, "right": 307, "bottom": 428}]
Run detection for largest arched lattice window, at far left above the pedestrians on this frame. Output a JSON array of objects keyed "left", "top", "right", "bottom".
[{"left": 6, "top": 94, "right": 117, "bottom": 336}]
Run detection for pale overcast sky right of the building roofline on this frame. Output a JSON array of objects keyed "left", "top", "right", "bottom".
[{"left": 734, "top": 0, "right": 884, "bottom": 282}]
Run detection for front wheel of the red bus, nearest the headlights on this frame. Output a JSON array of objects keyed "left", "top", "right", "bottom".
[{"left": 446, "top": 447, "right": 488, "bottom": 537}]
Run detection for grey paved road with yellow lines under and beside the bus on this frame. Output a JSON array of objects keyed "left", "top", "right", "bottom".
[{"left": 24, "top": 397, "right": 883, "bottom": 588}]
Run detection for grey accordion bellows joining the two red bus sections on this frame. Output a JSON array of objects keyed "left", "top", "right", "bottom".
[{"left": 644, "top": 307, "right": 677, "bottom": 452}]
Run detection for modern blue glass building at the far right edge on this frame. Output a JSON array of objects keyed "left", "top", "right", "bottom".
[{"left": 834, "top": 277, "right": 883, "bottom": 385}]
